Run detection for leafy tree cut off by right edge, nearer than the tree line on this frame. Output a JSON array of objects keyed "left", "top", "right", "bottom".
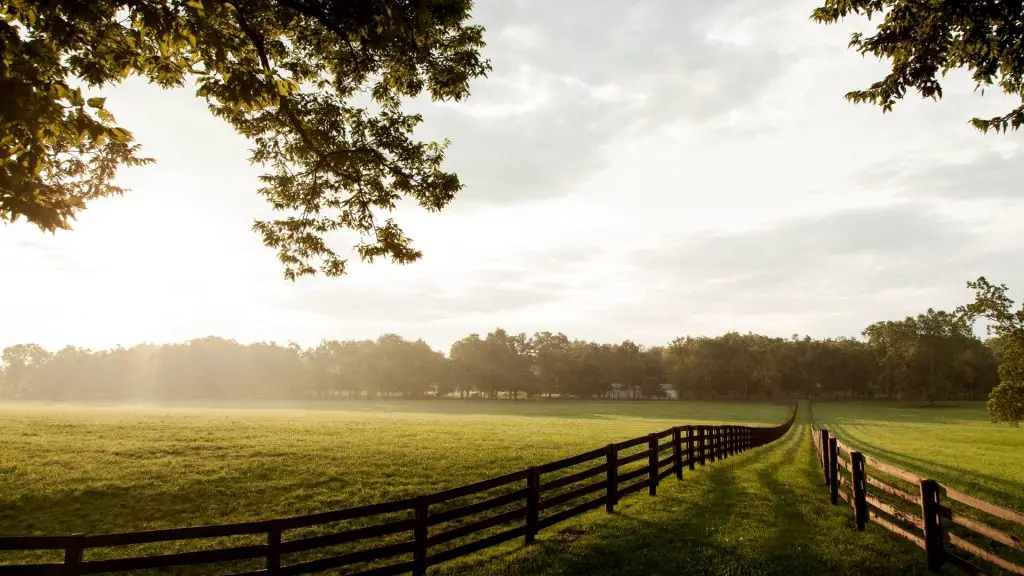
[{"left": 956, "top": 277, "right": 1024, "bottom": 426}]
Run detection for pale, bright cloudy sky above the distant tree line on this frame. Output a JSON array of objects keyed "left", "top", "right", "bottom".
[{"left": 0, "top": 0, "right": 1024, "bottom": 351}]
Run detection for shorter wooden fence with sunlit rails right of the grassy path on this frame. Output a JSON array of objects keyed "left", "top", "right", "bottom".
[{"left": 811, "top": 424, "right": 1024, "bottom": 575}]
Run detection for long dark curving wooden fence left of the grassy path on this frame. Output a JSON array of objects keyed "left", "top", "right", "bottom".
[{"left": 0, "top": 408, "right": 796, "bottom": 576}]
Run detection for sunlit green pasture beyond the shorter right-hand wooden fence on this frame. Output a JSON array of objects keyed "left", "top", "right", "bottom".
[{"left": 814, "top": 402, "right": 1024, "bottom": 510}]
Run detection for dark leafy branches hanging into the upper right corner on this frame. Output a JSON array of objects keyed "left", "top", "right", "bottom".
[{"left": 811, "top": 0, "right": 1024, "bottom": 132}]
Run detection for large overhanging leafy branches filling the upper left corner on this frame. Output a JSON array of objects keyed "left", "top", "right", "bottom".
[{"left": 0, "top": 0, "right": 489, "bottom": 280}]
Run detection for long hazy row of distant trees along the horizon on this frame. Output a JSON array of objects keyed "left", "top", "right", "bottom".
[{"left": 0, "top": 303, "right": 1006, "bottom": 401}]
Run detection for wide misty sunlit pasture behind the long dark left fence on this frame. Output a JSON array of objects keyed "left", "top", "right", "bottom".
[{"left": 0, "top": 401, "right": 788, "bottom": 564}]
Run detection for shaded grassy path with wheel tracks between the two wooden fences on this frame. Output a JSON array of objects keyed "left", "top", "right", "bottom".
[{"left": 436, "top": 406, "right": 925, "bottom": 576}]
